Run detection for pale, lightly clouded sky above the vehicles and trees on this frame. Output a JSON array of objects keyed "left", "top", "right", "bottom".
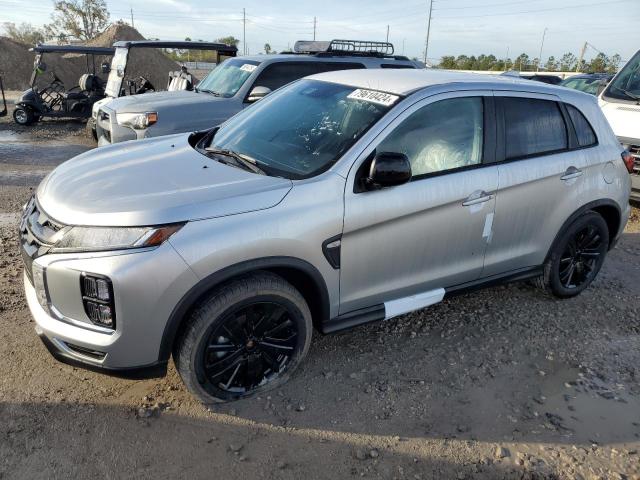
[{"left": 0, "top": 0, "right": 640, "bottom": 62}]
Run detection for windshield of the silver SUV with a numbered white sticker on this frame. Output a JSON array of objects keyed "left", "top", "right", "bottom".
[{"left": 204, "top": 80, "right": 399, "bottom": 179}]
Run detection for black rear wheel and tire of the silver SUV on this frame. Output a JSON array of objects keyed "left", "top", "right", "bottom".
[{"left": 534, "top": 211, "right": 609, "bottom": 298}]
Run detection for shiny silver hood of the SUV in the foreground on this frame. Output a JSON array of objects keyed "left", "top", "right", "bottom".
[{"left": 37, "top": 134, "right": 292, "bottom": 226}]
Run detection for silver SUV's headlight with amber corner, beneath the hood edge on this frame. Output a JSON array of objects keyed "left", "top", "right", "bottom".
[{"left": 51, "top": 223, "right": 184, "bottom": 253}]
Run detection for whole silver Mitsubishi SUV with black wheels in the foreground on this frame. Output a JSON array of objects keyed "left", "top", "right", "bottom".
[{"left": 20, "top": 70, "right": 629, "bottom": 403}]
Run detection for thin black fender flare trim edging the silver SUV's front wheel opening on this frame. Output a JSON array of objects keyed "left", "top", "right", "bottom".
[{"left": 158, "top": 256, "right": 329, "bottom": 362}]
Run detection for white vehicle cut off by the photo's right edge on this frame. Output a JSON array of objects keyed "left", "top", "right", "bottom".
[{"left": 598, "top": 50, "right": 640, "bottom": 201}]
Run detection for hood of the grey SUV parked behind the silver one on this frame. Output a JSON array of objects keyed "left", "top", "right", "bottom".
[{"left": 108, "top": 90, "right": 229, "bottom": 113}]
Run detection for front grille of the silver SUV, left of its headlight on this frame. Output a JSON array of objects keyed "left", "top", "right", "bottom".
[{"left": 20, "top": 196, "right": 64, "bottom": 283}]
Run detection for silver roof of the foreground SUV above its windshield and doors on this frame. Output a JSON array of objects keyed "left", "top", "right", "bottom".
[{"left": 307, "top": 68, "right": 558, "bottom": 95}]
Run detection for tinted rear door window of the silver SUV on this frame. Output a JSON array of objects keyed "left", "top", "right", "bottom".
[{"left": 502, "top": 97, "right": 567, "bottom": 160}]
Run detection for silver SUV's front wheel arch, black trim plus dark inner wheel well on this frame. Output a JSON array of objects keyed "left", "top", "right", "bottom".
[{"left": 159, "top": 257, "right": 329, "bottom": 362}]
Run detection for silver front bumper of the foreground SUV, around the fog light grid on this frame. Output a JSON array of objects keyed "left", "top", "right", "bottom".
[{"left": 24, "top": 243, "right": 197, "bottom": 373}]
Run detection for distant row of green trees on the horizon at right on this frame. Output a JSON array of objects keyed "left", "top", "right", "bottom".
[{"left": 437, "top": 52, "right": 621, "bottom": 73}]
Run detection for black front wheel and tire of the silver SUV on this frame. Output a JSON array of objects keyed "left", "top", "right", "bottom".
[{"left": 173, "top": 272, "right": 313, "bottom": 404}]
